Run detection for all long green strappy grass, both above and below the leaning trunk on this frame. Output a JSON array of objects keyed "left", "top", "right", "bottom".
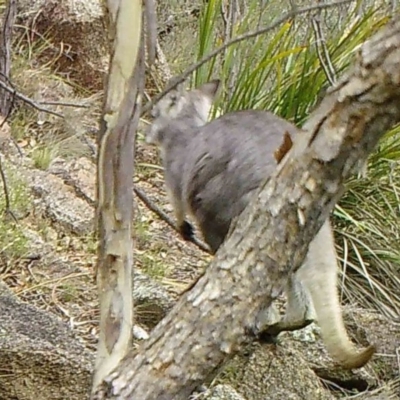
[{"left": 193, "top": 0, "right": 400, "bottom": 316}]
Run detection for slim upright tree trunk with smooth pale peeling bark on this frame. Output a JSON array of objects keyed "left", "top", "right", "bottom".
[{"left": 93, "top": 0, "right": 148, "bottom": 390}]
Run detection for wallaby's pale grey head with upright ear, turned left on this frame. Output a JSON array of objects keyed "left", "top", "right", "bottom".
[{"left": 146, "top": 79, "right": 220, "bottom": 145}]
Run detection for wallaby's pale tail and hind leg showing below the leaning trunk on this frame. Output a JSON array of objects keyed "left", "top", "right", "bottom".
[{"left": 263, "top": 221, "right": 375, "bottom": 369}]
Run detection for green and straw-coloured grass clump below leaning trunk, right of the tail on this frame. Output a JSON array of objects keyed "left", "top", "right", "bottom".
[{"left": 335, "top": 126, "right": 400, "bottom": 318}]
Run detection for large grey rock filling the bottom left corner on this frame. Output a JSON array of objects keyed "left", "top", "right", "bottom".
[{"left": 0, "top": 284, "right": 94, "bottom": 400}]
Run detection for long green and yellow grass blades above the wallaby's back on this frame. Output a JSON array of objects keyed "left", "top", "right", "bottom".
[{"left": 194, "top": 0, "right": 388, "bottom": 124}]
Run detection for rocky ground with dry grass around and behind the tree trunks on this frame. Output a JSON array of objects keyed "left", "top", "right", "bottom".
[{"left": 0, "top": 0, "right": 400, "bottom": 400}]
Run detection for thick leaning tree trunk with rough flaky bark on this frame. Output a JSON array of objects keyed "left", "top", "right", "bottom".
[{"left": 94, "top": 19, "right": 400, "bottom": 400}]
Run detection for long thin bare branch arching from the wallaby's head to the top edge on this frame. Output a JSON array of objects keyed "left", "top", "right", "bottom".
[{"left": 141, "top": 0, "right": 354, "bottom": 115}]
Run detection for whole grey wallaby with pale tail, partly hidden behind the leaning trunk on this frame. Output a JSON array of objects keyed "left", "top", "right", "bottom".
[{"left": 147, "top": 80, "right": 375, "bottom": 369}]
